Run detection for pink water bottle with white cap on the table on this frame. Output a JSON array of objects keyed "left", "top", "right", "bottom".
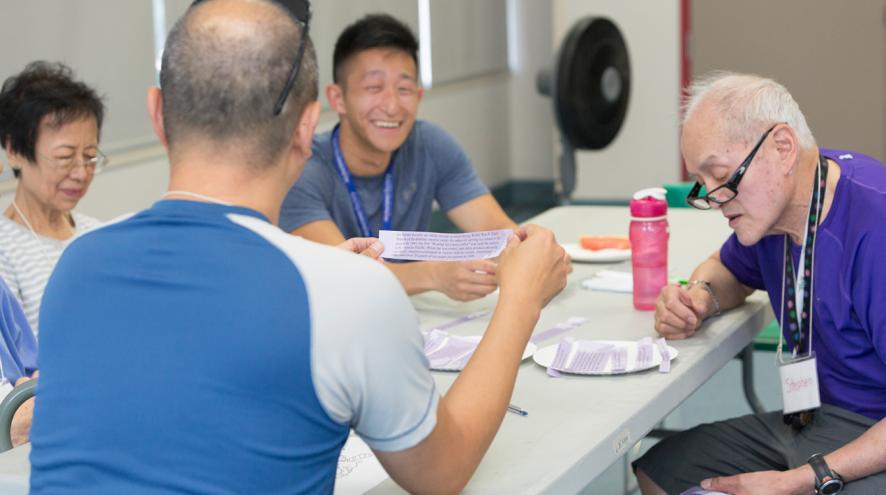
[{"left": 630, "top": 187, "right": 669, "bottom": 310}]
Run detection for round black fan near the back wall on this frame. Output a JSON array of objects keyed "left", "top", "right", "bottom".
[{"left": 536, "top": 17, "right": 631, "bottom": 203}]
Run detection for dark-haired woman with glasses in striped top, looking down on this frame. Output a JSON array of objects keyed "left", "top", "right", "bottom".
[{"left": 0, "top": 62, "right": 106, "bottom": 334}]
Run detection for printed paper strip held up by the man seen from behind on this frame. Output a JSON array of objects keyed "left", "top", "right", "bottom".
[{"left": 378, "top": 230, "right": 514, "bottom": 261}]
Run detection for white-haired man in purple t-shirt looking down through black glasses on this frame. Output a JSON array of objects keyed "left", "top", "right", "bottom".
[{"left": 634, "top": 73, "right": 886, "bottom": 495}]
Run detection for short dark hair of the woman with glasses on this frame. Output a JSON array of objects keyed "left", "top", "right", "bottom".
[{"left": 0, "top": 61, "right": 105, "bottom": 177}]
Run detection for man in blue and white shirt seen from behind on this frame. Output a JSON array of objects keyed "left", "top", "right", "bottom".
[{"left": 31, "top": 0, "right": 568, "bottom": 494}]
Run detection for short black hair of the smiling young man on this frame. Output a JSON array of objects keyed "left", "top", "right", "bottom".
[{"left": 332, "top": 14, "right": 418, "bottom": 84}]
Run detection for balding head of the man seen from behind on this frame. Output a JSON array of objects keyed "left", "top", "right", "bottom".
[{"left": 160, "top": 0, "right": 317, "bottom": 166}]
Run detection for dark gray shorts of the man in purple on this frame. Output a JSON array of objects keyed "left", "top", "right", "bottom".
[{"left": 634, "top": 404, "right": 886, "bottom": 494}]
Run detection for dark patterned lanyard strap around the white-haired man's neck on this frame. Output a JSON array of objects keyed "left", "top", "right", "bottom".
[{"left": 778, "top": 156, "right": 828, "bottom": 361}]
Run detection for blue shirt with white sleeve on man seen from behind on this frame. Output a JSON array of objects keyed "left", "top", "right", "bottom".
[{"left": 31, "top": 200, "right": 438, "bottom": 494}]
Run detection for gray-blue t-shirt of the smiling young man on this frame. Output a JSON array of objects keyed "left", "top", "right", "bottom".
[{"left": 280, "top": 120, "right": 489, "bottom": 238}]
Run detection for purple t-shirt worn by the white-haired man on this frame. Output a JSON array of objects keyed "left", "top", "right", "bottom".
[{"left": 720, "top": 149, "right": 886, "bottom": 420}]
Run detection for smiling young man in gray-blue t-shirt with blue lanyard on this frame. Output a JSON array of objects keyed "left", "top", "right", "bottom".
[{"left": 280, "top": 15, "right": 516, "bottom": 301}]
